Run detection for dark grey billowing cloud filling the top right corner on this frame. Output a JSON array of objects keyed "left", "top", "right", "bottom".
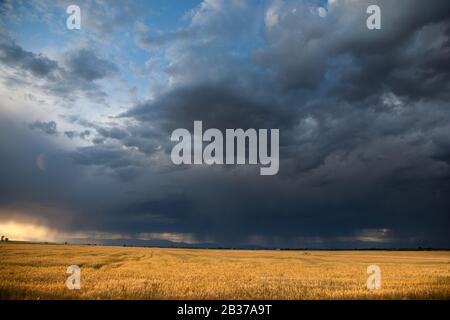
[{"left": 256, "top": 0, "right": 450, "bottom": 100}]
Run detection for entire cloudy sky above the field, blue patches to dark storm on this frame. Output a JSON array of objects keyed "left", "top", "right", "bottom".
[{"left": 0, "top": 0, "right": 450, "bottom": 248}]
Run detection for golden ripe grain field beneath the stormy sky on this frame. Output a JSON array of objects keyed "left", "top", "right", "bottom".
[{"left": 0, "top": 243, "right": 450, "bottom": 299}]
